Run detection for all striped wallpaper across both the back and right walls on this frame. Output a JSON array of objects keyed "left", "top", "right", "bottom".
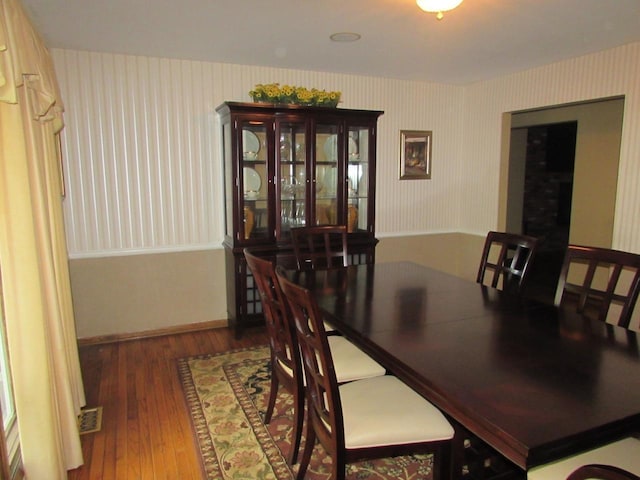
[{"left": 52, "top": 44, "right": 640, "bottom": 257}]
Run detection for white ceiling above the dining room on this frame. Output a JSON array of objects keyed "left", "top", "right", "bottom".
[{"left": 21, "top": 0, "right": 640, "bottom": 84}]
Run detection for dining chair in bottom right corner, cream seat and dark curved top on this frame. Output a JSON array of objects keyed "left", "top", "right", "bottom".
[{"left": 527, "top": 437, "right": 640, "bottom": 480}]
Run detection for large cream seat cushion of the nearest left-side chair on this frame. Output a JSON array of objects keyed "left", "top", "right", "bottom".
[{"left": 340, "top": 375, "right": 453, "bottom": 448}]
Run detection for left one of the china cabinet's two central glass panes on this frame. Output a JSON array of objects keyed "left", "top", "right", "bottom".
[{"left": 277, "top": 121, "right": 309, "bottom": 237}]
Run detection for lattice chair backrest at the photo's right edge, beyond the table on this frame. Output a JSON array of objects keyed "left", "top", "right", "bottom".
[{"left": 554, "top": 245, "right": 640, "bottom": 327}]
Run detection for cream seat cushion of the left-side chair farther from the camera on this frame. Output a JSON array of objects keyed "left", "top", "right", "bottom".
[{"left": 327, "top": 335, "right": 386, "bottom": 383}]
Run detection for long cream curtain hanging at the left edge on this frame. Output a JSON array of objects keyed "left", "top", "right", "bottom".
[{"left": 0, "top": 0, "right": 85, "bottom": 480}]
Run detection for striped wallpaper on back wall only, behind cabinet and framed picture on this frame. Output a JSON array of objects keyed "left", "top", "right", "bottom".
[{"left": 52, "top": 50, "right": 463, "bottom": 258}]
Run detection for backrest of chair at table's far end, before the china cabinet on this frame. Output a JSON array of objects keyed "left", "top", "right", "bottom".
[{"left": 291, "top": 225, "right": 349, "bottom": 270}]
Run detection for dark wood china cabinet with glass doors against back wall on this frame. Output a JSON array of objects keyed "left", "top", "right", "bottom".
[{"left": 216, "top": 102, "right": 383, "bottom": 335}]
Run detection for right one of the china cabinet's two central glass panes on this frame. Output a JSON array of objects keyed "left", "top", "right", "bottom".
[{"left": 314, "top": 125, "right": 342, "bottom": 225}]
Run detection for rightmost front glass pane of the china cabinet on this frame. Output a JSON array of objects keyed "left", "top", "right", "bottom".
[{"left": 347, "top": 127, "right": 370, "bottom": 232}]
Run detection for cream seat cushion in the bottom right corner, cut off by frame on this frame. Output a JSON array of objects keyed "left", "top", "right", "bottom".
[{"left": 527, "top": 437, "right": 640, "bottom": 480}]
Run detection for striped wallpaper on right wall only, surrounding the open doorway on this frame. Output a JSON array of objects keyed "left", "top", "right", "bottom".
[{"left": 460, "top": 43, "right": 640, "bottom": 252}]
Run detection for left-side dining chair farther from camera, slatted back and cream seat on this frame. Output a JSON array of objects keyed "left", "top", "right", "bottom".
[{"left": 244, "top": 249, "right": 386, "bottom": 465}]
